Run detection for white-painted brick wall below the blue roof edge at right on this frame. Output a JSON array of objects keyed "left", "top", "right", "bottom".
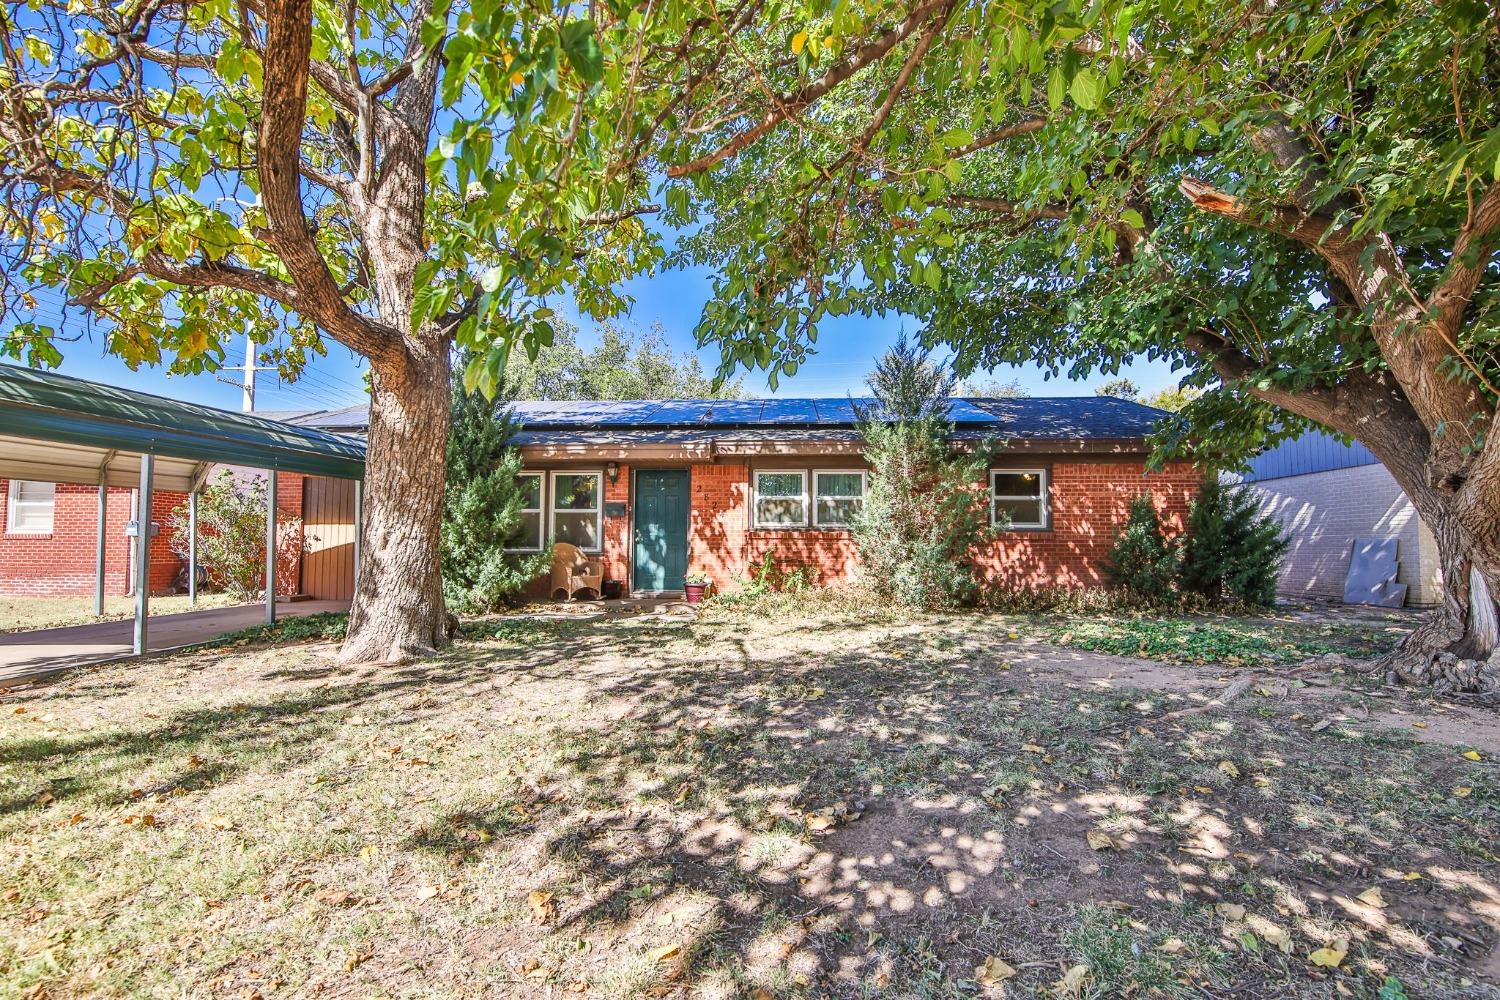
[{"left": 1244, "top": 465, "right": 1443, "bottom": 606}]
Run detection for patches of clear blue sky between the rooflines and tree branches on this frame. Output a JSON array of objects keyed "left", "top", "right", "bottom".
[{"left": 23, "top": 262, "right": 1176, "bottom": 411}]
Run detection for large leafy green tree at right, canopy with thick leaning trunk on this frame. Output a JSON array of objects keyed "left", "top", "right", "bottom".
[{"left": 609, "top": 0, "right": 1500, "bottom": 678}]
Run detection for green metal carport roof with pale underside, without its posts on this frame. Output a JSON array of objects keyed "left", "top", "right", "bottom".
[{"left": 0, "top": 364, "right": 365, "bottom": 492}]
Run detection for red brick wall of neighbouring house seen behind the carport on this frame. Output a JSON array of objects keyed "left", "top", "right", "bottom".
[{"left": 0, "top": 480, "right": 186, "bottom": 597}]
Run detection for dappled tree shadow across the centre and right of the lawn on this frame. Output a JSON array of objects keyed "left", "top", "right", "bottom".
[{"left": 396, "top": 628, "right": 1500, "bottom": 996}]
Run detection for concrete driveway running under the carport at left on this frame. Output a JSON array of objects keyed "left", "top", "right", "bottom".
[{"left": 0, "top": 601, "right": 350, "bottom": 687}]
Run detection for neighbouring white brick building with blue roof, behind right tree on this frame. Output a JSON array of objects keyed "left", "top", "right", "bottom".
[{"left": 1230, "top": 432, "right": 1443, "bottom": 606}]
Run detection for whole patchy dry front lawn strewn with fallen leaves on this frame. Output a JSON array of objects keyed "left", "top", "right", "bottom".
[{"left": 0, "top": 607, "right": 1500, "bottom": 1000}]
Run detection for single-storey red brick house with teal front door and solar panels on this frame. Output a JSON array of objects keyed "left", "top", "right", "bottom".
[{"left": 498, "top": 396, "right": 1200, "bottom": 594}]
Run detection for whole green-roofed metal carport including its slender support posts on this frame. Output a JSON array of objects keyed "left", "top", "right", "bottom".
[{"left": 0, "top": 364, "right": 365, "bottom": 655}]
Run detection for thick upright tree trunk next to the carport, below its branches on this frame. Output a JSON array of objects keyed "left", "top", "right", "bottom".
[{"left": 339, "top": 337, "right": 453, "bottom": 663}]
